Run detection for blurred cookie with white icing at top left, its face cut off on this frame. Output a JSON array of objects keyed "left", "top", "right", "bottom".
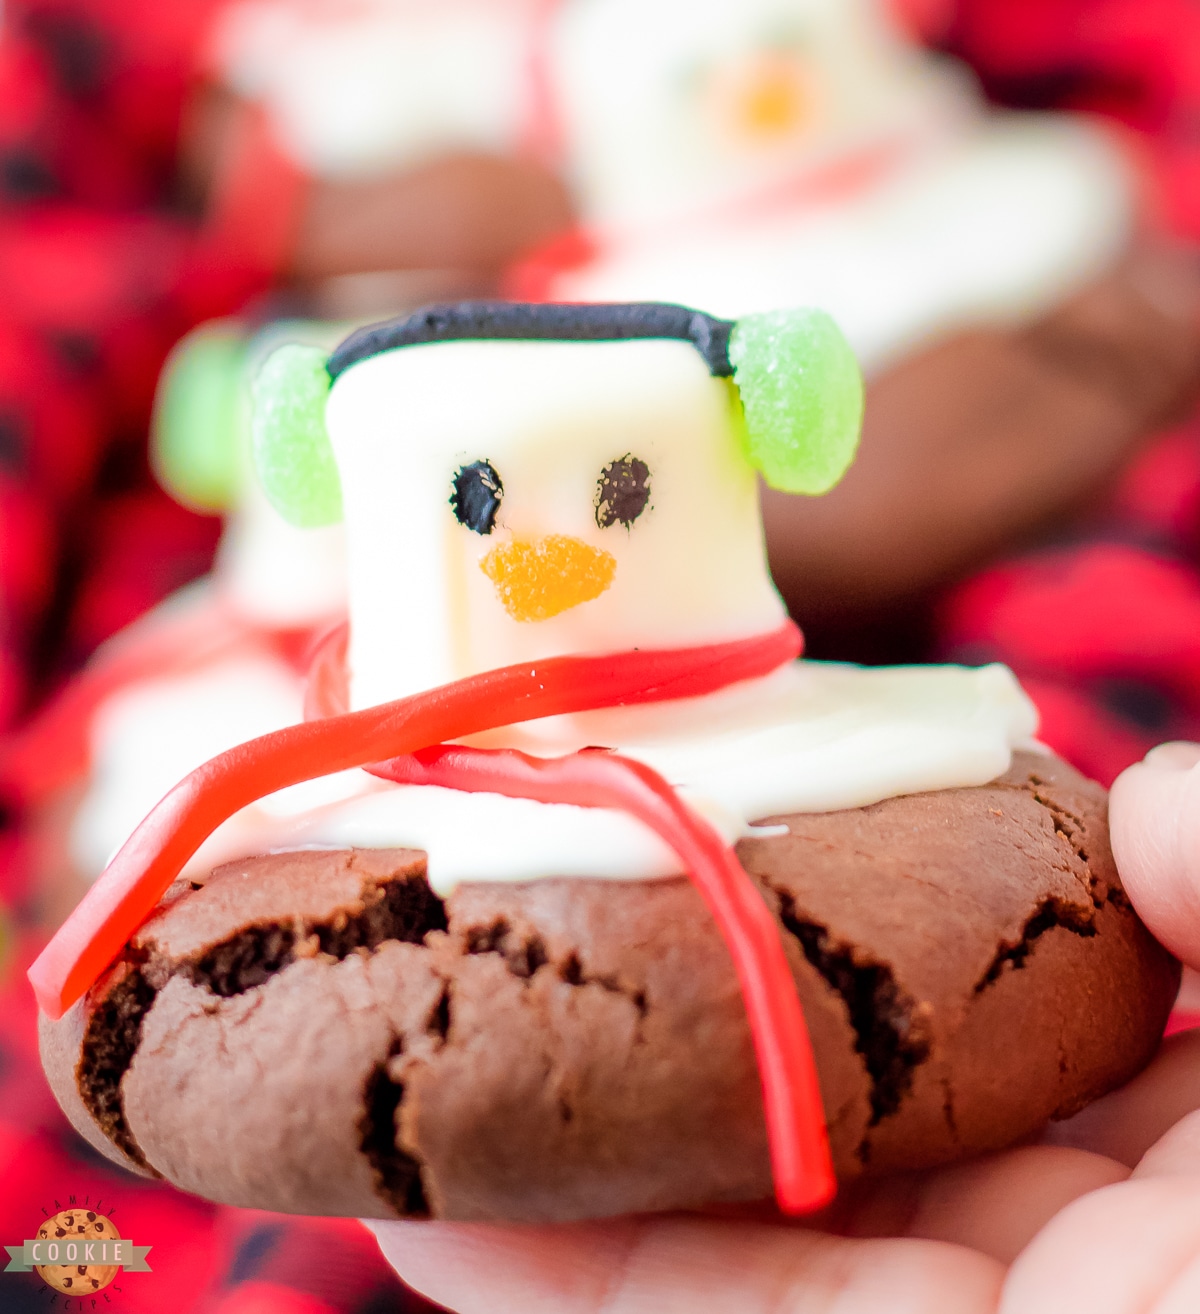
[{"left": 189, "top": 0, "right": 572, "bottom": 295}]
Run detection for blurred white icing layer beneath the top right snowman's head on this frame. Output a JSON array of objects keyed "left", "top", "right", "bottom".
[{"left": 552, "top": 114, "right": 1133, "bottom": 373}]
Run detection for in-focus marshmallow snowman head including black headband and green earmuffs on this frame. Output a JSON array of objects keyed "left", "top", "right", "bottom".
[{"left": 254, "top": 302, "right": 862, "bottom": 707}]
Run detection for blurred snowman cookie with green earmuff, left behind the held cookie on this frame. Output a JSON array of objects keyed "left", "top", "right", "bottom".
[{"left": 0, "top": 319, "right": 346, "bottom": 926}]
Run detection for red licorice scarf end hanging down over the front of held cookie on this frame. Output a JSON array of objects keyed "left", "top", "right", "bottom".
[{"left": 369, "top": 745, "right": 836, "bottom": 1214}]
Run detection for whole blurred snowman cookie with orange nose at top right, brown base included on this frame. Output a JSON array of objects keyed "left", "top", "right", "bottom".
[{"left": 523, "top": 0, "right": 1200, "bottom": 635}]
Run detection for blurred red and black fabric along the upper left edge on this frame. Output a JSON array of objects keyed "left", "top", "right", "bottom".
[{"left": 0, "top": 0, "right": 265, "bottom": 728}]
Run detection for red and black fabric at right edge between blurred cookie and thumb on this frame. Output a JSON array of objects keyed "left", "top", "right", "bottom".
[{"left": 938, "top": 422, "right": 1200, "bottom": 784}]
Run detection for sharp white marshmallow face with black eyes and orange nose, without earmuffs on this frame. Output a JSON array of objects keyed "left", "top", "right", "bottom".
[{"left": 326, "top": 340, "right": 783, "bottom": 707}]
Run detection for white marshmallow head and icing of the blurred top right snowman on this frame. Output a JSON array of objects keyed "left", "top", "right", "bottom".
[{"left": 549, "top": 0, "right": 1134, "bottom": 372}]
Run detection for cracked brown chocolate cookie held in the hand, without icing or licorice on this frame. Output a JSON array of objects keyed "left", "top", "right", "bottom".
[{"left": 42, "top": 754, "right": 1179, "bottom": 1221}]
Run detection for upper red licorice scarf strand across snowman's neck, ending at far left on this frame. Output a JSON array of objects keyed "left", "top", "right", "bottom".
[{"left": 29, "top": 622, "right": 802, "bottom": 1017}]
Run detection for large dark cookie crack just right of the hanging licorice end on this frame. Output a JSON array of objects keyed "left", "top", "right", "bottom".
[{"left": 774, "top": 890, "right": 931, "bottom": 1140}]
